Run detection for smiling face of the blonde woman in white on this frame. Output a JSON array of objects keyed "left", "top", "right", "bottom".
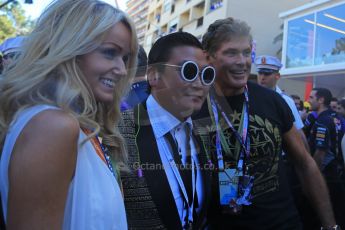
[{"left": 79, "top": 22, "right": 131, "bottom": 103}]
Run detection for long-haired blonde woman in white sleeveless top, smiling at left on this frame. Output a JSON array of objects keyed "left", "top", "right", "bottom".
[{"left": 0, "top": 0, "right": 137, "bottom": 229}]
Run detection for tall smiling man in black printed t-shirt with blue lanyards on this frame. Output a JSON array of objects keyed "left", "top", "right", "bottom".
[{"left": 198, "top": 18, "right": 335, "bottom": 230}]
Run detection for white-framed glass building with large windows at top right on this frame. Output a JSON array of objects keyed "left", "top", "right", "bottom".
[{"left": 279, "top": 0, "right": 345, "bottom": 99}]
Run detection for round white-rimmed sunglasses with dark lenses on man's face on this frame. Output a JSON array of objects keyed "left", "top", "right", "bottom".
[{"left": 162, "top": 61, "right": 216, "bottom": 85}]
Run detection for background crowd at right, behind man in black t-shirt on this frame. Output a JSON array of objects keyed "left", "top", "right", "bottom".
[{"left": 255, "top": 55, "right": 345, "bottom": 229}]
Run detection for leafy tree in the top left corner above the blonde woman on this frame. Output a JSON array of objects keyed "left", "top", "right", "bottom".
[{"left": 0, "top": 0, "right": 33, "bottom": 43}]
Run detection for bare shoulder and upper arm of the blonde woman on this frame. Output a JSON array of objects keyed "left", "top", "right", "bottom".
[{"left": 8, "top": 109, "right": 79, "bottom": 228}]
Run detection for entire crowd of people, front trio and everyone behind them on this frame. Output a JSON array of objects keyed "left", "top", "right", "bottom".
[{"left": 0, "top": 0, "right": 345, "bottom": 230}]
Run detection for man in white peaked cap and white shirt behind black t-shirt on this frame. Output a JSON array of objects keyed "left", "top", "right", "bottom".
[{"left": 255, "top": 55, "right": 309, "bottom": 150}]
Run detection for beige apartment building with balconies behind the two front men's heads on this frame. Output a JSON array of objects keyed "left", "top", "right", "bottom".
[{"left": 144, "top": 0, "right": 310, "bottom": 55}]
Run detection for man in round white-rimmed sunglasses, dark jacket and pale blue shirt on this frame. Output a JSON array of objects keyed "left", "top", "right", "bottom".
[{"left": 120, "top": 32, "right": 216, "bottom": 229}]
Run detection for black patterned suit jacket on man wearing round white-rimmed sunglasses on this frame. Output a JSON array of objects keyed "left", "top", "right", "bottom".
[{"left": 119, "top": 102, "right": 211, "bottom": 229}]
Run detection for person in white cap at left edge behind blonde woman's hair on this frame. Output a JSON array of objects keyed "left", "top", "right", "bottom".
[{"left": 0, "top": 36, "right": 24, "bottom": 69}]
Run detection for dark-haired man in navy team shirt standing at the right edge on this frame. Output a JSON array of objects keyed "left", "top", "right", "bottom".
[{"left": 309, "top": 88, "right": 345, "bottom": 229}]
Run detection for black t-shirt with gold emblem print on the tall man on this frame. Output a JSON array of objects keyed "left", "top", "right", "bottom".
[{"left": 194, "top": 82, "right": 299, "bottom": 230}]
